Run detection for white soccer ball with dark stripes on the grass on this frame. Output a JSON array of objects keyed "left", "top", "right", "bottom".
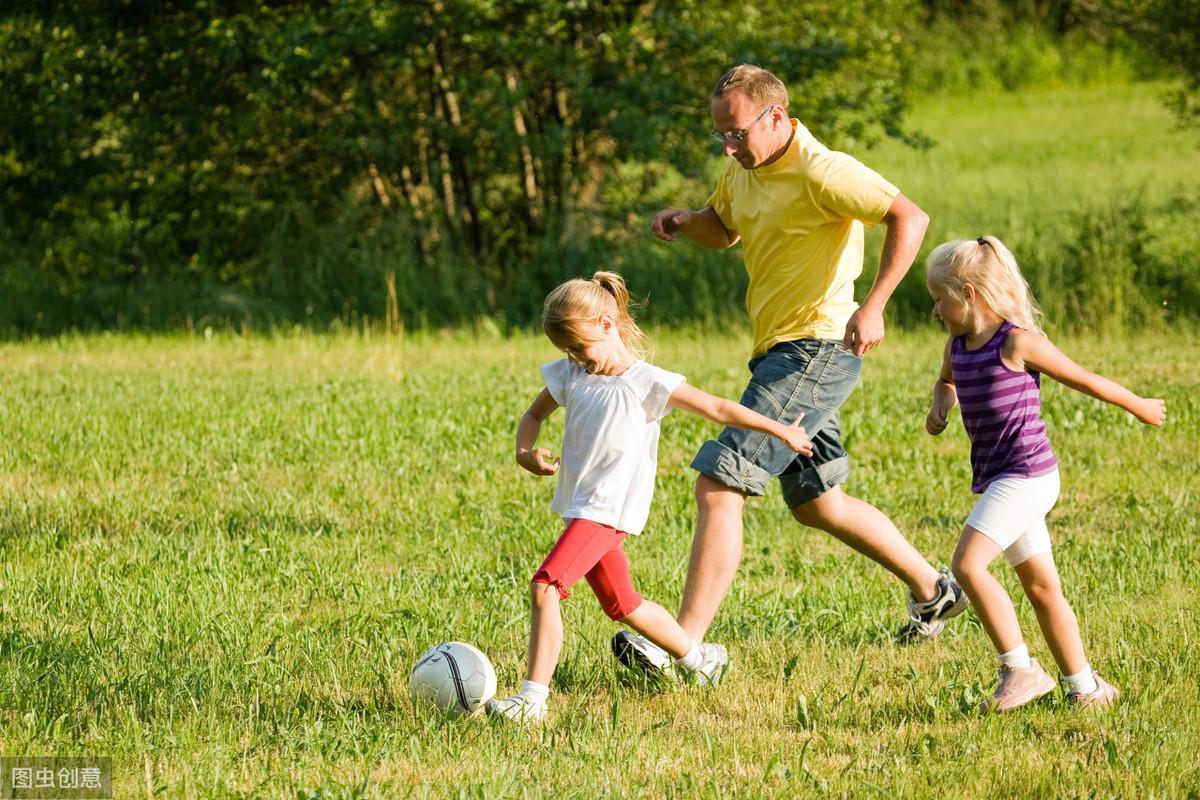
[{"left": 408, "top": 642, "right": 496, "bottom": 717}]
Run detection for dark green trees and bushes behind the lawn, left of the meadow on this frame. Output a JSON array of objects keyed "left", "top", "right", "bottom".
[{"left": 0, "top": 0, "right": 1187, "bottom": 333}]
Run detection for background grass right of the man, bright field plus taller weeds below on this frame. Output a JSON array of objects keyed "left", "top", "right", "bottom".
[{"left": 856, "top": 83, "right": 1200, "bottom": 331}]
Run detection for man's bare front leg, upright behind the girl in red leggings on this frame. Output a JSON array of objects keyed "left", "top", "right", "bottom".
[{"left": 679, "top": 475, "right": 746, "bottom": 642}]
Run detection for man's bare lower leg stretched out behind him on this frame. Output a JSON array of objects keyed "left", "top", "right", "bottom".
[{"left": 792, "top": 486, "right": 937, "bottom": 599}]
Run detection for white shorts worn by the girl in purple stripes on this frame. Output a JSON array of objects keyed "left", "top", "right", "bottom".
[{"left": 966, "top": 470, "right": 1058, "bottom": 566}]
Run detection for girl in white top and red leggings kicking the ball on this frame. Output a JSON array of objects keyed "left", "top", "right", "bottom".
[{"left": 487, "top": 272, "right": 812, "bottom": 722}]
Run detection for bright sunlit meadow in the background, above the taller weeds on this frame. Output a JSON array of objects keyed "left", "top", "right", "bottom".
[{"left": 858, "top": 83, "right": 1200, "bottom": 246}]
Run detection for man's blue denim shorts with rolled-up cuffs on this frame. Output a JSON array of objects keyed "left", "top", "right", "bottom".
[{"left": 691, "top": 339, "right": 863, "bottom": 509}]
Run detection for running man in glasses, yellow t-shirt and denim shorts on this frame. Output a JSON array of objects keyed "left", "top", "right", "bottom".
[{"left": 613, "top": 65, "right": 967, "bottom": 672}]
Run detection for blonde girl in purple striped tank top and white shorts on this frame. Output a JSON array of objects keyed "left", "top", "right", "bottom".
[{"left": 925, "top": 236, "right": 1166, "bottom": 711}]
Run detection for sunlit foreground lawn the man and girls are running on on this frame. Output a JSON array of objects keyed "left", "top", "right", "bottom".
[{"left": 0, "top": 332, "right": 1200, "bottom": 798}]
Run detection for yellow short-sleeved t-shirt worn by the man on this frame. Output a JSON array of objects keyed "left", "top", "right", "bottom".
[{"left": 707, "top": 119, "right": 900, "bottom": 355}]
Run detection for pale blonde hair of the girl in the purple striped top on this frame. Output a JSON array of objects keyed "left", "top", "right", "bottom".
[{"left": 925, "top": 236, "right": 1043, "bottom": 333}]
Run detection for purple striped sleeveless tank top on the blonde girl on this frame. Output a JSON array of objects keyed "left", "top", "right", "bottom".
[{"left": 950, "top": 320, "right": 1058, "bottom": 493}]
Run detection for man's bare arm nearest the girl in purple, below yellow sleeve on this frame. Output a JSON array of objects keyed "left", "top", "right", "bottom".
[{"left": 842, "top": 194, "right": 929, "bottom": 355}]
